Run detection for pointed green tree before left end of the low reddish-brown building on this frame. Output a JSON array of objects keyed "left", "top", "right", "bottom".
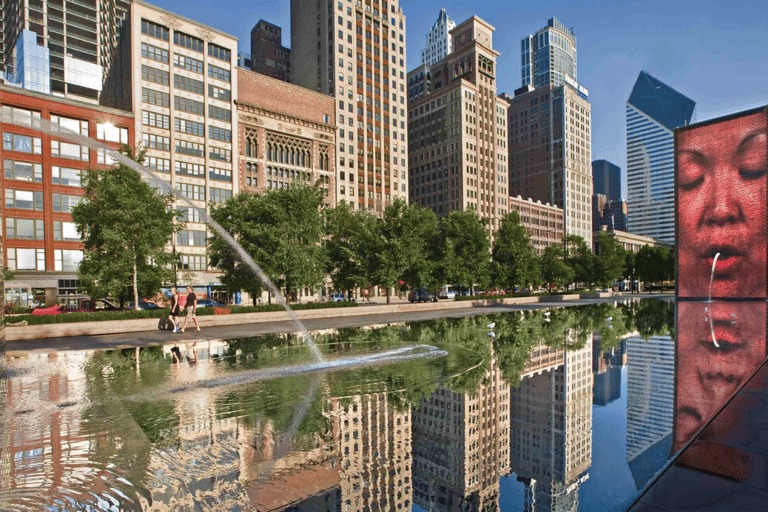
[{"left": 492, "top": 211, "right": 539, "bottom": 288}]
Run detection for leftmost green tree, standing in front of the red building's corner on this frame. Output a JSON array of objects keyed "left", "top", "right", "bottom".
[{"left": 72, "top": 146, "right": 177, "bottom": 309}]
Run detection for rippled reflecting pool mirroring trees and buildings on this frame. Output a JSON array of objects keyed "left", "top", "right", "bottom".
[{"left": 0, "top": 300, "right": 701, "bottom": 512}]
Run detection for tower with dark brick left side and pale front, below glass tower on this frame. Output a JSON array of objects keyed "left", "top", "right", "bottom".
[{"left": 501, "top": 81, "right": 592, "bottom": 247}]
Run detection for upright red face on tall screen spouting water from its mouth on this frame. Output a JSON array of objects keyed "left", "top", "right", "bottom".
[{"left": 677, "top": 112, "right": 766, "bottom": 297}]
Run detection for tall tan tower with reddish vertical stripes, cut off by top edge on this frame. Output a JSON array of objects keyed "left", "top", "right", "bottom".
[{"left": 291, "top": 0, "right": 408, "bottom": 215}]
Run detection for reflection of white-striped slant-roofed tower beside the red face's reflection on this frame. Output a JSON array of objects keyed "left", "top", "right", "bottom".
[{"left": 627, "top": 336, "right": 675, "bottom": 489}]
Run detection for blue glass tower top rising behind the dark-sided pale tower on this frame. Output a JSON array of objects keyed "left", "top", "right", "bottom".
[{"left": 520, "top": 18, "right": 578, "bottom": 88}]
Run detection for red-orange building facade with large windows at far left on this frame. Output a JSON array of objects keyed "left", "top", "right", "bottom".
[{"left": 0, "top": 86, "right": 135, "bottom": 307}]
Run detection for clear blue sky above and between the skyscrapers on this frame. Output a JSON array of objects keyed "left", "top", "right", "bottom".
[{"left": 150, "top": 0, "right": 768, "bottom": 196}]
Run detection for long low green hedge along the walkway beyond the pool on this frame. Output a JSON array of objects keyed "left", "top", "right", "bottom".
[{"left": 5, "top": 302, "right": 357, "bottom": 325}]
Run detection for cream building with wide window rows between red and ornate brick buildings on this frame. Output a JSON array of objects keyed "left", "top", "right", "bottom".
[{"left": 131, "top": 0, "right": 238, "bottom": 285}]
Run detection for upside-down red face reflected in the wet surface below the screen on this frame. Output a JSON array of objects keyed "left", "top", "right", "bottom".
[{"left": 675, "top": 301, "right": 766, "bottom": 450}]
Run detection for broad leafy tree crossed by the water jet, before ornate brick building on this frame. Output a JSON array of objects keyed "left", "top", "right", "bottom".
[{"left": 208, "top": 185, "right": 327, "bottom": 304}]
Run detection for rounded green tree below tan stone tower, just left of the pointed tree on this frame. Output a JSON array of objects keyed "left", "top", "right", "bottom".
[{"left": 438, "top": 210, "right": 491, "bottom": 294}]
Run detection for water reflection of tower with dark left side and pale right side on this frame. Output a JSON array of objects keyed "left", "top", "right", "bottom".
[{"left": 510, "top": 334, "right": 592, "bottom": 512}]
